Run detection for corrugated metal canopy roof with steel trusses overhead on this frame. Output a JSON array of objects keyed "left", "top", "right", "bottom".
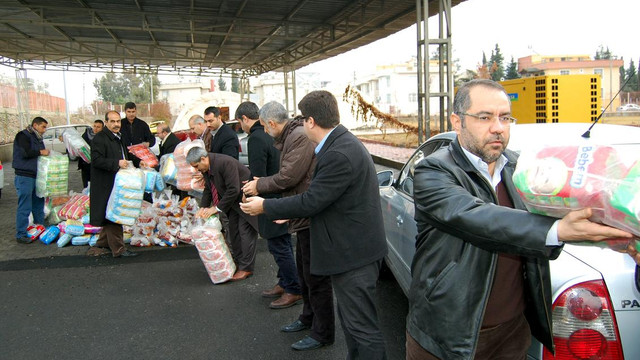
[{"left": 0, "top": 0, "right": 463, "bottom": 76}]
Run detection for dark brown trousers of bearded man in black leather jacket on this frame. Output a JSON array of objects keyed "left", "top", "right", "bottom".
[{"left": 406, "top": 314, "right": 531, "bottom": 360}]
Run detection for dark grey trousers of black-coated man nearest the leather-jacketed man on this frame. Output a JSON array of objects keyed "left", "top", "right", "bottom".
[{"left": 331, "top": 259, "right": 387, "bottom": 360}]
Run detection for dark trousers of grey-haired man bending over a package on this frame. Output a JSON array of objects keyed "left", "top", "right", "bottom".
[{"left": 227, "top": 209, "right": 258, "bottom": 272}]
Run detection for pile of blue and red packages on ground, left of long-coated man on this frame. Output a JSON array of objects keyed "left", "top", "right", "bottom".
[{"left": 36, "top": 192, "right": 101, "bottom": 247}]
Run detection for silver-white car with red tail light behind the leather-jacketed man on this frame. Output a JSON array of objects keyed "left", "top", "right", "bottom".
[{"left": 378, "top": 123, "right": 640, "bottom": 359}]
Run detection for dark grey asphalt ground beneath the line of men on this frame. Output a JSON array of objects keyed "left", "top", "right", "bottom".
[{"left": 0, "top": 162, "right": 407, "bottom": 360}]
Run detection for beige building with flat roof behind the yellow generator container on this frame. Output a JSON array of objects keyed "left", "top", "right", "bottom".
[{"left": 518, "top": 55, "right": 624, "bottom": 111}]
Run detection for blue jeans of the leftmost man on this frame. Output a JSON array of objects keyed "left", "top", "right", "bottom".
[{"left": 13, "top": 175, "right": 44, "bottom": 239}]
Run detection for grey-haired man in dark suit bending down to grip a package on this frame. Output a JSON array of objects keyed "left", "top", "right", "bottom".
[{"left": 187, "top": 147, "right": 258, "bottom": 281}]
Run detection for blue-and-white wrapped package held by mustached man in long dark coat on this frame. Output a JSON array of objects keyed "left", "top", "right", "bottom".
[{"left": 106, "top": 163, "right": 145, "bottom": 225}]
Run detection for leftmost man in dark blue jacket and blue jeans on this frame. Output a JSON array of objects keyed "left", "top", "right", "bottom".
[{"left": 12, "top": 116, "right": 49, "bottom": 244}]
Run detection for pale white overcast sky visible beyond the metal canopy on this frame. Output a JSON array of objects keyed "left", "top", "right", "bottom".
[{"left": 0, "top": 0, "right": 640, "bottom": 110}]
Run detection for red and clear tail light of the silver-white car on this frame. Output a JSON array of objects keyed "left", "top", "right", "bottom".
[{"left": 543, "top": 280, "right": 624, "bottom": 360}]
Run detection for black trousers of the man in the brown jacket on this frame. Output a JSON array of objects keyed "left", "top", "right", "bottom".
[{"left": 296, "top": 229, "right": 335, "bottom": 343}]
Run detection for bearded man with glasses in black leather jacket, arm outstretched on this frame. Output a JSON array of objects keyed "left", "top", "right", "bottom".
[{"left": 406, "top": 80, "right": 631, "bottom": 359}]
